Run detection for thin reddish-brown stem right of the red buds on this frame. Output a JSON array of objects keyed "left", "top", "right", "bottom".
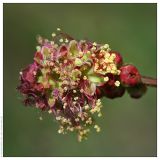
[{"left": 141, "top": 76, "right": 157, "bottom": 87}]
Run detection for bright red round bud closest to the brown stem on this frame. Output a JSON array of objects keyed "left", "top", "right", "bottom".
[{"left": 120, "top": 64, "right": 141, "bottom": 86}]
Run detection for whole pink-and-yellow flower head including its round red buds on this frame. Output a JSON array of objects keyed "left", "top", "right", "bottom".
[{"left": 17, "top": 28, "right": 146, "bottom": 141}]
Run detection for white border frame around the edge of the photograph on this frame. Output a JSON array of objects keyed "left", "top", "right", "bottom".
[{"left": 0, "top": 0, "right": 160, "bottom": 160}]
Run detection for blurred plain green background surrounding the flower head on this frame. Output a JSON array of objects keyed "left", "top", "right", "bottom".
[{"left": 3, "top": 4, "right": 157, "bottom": 156}]
